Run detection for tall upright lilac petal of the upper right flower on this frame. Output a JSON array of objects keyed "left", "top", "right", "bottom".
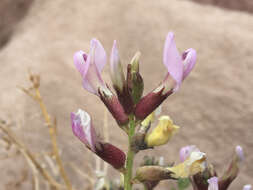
[{"left": 163, "top": 32, "right": 184, "bottom": 91}]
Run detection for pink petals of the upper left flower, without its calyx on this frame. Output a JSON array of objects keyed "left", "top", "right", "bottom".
[{"left": 74, "top": 39, "right": 106, "bottom": 95}]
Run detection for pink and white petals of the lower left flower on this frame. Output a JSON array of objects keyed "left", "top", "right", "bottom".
[{"left": 71, "top": 109, "right": 96, "bottom": 152}]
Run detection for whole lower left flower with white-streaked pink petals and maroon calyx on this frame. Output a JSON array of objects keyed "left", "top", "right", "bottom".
[{"left": 71, "top": 109, "right": 126, "bottom": 169}]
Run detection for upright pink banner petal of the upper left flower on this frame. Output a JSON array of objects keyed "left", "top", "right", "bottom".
[{"left": 90, "top": 39, "right": 106, "bottom": 73}]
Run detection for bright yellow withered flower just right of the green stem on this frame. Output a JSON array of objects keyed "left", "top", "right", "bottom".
[{"left": 145, "top": 116, "right": 179, "bottom": 147}]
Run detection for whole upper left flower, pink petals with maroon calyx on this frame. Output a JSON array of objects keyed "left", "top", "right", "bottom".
[{"left": 74, "top": 39, "right": 128, "bottom": 125}]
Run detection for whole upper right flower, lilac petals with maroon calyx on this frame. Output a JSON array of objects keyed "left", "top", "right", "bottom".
[{"left": 135, "top": 32, "right": 196, "bottom": 120}]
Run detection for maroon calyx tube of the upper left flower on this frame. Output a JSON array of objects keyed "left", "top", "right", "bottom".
[{"left": 98, "top": 87, "right": 128, "bottom": 126}]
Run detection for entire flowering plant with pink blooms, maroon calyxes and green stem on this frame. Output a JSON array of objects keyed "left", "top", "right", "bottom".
[{"left": 71, "top": 32, "right": 251, "bottom": 190}]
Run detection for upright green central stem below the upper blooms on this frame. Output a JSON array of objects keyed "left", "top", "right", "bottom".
[{"left": 124, "top": 116, "right": 135, "bottom": 190}]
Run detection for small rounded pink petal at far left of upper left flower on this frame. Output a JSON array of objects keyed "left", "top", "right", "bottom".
[{"left": 74, "top": 51, "right": 89, "bottom": 77}]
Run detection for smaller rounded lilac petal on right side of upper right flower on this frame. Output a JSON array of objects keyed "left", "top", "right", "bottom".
[{"left": 182, "top": 48, "right": 197, "bottom": 80}]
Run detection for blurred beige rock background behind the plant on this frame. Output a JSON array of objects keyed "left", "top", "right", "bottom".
[{"left": 0, "top": 0, "right": 253, "bottom": 190}]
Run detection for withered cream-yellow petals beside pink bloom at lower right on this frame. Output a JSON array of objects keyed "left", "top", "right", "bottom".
[{"left": 167, "top": 152, "right": 206, "bottom": 178}]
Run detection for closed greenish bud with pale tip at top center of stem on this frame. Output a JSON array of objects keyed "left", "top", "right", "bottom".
[{"left": 127, "top": 52, "right": 144, "bottom": 104}]
